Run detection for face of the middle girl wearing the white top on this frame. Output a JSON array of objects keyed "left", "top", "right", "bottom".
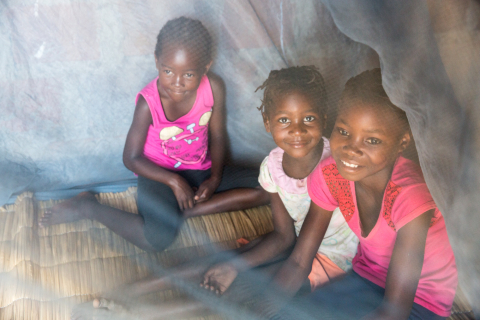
[{"left": 262, "top": 92, "right": 325, "bottom": 158}]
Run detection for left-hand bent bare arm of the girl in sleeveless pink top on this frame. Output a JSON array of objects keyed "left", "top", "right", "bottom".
[{"left": 123, "top": 96, "right": 194, "bottom": 210}]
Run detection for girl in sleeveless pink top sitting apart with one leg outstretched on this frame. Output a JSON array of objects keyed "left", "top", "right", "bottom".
[{"left": 39, "top": 17, "right": 268, "bottom": 251}]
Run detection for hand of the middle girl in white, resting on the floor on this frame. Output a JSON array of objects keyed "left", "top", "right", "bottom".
[{"left": 200, "top": 263, "right": 238, "bottom": 294}]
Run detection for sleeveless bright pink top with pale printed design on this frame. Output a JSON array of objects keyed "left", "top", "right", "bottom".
[{"left": 136, "top": 75, "right": 214, "bottom": 170}]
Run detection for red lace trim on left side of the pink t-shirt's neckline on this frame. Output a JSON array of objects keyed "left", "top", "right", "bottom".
[{"left": 322, "top": 163, "right": 355, "bottom": 222}]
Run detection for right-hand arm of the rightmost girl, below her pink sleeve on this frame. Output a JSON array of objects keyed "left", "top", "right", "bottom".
[{"left": 364, "top": 209, "right": 434, "bottom": 319}]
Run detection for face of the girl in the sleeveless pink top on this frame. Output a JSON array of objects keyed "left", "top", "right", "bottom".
[{"left": 155, "top": 44, "right": 211, "bottom": 103}]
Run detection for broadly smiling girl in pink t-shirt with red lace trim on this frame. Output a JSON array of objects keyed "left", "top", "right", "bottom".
[{"left": 274, "top": 69, "right": 457, "bottom": 319}]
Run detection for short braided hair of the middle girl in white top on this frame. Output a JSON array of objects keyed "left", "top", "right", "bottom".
[{"left": 255, "top": 66, "right": 327, "bottom": 116}]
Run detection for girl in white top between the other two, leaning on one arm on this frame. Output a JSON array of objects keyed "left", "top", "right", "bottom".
[{"left": 203, "top": 66, "right": 358, "bottom": 293}]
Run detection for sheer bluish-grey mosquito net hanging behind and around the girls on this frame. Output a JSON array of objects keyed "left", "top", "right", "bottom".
[{"left": 0, "top": 0, "right": 480, "bottom": 314}]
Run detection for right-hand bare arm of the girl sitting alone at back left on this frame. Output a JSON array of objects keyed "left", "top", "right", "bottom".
[{"left": 195, "top": 73, "right": 227, "bottom": 202}]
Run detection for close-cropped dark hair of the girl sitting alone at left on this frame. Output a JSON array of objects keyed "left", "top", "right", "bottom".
[{"left": 155, "top": 17, "right": 212, "bottom": 64}]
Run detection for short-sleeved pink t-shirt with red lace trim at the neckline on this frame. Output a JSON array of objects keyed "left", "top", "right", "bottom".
[{"left": 307, "top": 157, "right": 457, "bottom": 317}]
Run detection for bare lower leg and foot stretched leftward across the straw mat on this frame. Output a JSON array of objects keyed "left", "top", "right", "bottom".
[{"left": 38, "top": 192, "right": 156, "bottom": 251}]
